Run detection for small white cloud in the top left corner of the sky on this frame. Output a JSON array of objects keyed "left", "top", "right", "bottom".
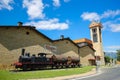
[{"left": 0, "top": 0, "right": 14, "bottom": 10}]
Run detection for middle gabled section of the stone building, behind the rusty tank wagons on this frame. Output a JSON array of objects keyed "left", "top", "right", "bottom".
[{"left": 53, "top": 37, "right": 80, "bottom": 58}]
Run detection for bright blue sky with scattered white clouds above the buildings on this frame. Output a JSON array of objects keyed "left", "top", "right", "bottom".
[{"left": 0, "top": 0, "right": 120, "bottom": 52}]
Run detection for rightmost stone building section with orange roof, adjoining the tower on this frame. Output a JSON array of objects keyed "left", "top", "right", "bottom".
[{"left": 74, "top": 38, "right": 95, "bottom": 66}]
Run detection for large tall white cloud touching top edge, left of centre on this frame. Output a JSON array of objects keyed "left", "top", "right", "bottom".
[{"left": 23, "top": 0, "right": 45, "bottom": 19}]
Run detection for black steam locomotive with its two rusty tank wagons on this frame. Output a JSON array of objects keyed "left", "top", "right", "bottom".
[{"left": 14, "top": 49, "right": 80, "bottom": 70}]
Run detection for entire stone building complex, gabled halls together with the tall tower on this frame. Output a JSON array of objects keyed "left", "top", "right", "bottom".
[{"left": 0, "top": 22, "right": 104, "bottom": 65}]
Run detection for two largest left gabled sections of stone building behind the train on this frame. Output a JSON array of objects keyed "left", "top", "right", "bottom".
[{"left": 0, "top": 23, "right": 79, "bottom": 64}]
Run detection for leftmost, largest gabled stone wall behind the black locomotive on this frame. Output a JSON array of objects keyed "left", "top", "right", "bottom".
[{"left": 0, "top": 26, "right": 52, "bottom": 64}]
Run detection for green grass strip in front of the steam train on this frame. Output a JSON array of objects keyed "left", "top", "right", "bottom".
[{"left": 0, "top": 66, "right": 93, "bottom": 80}]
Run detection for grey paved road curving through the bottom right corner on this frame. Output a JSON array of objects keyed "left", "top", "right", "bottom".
[{"left": 69, "top": 67, "right": 120, "bottom": 80}]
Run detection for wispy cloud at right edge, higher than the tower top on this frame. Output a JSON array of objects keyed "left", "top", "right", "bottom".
[{"left": 101, "top": 10, "right": 120, "bottom": 19}]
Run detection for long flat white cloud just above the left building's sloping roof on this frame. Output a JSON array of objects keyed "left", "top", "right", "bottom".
[{"left": 25, "top": 18, "right": 69, "bottom": 30}]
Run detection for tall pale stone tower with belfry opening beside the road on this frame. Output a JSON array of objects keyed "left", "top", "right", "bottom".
[{"left": 89, "top": 21, "right": 105, "bottom": 65}]
